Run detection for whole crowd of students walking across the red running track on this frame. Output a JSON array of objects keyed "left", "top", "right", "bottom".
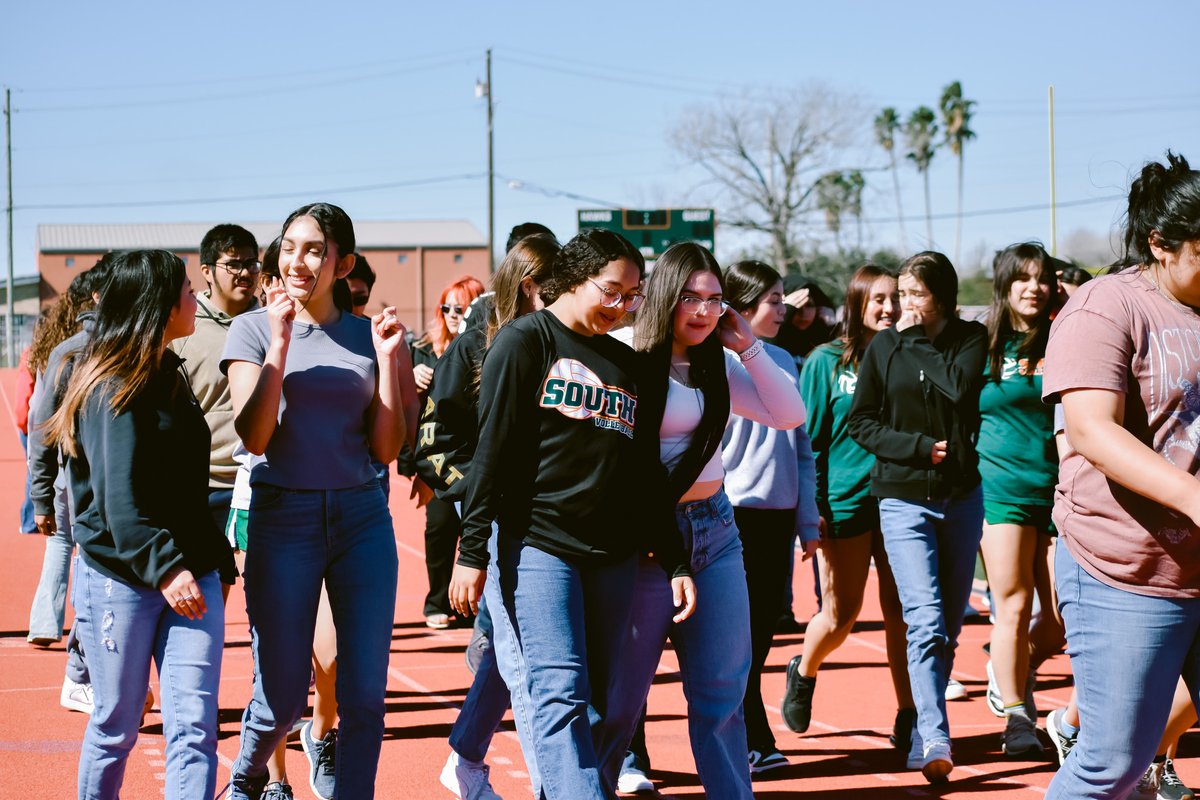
[{"left": 16, "top": 154, "right": 1200, "bottom": 800}]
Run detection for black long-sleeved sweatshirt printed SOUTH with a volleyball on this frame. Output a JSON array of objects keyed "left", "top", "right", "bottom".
[{"left": 458, "top": 311, "right": 685, "bottom": 575}]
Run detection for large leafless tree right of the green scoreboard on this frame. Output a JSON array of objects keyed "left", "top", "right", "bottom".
[{"left": 671, "top": 85, "right": 866, "bottom": 271}]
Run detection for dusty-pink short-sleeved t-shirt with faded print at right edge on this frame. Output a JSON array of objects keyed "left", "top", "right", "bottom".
[{"left": 1042, "top": 270, "right": 1200, "bottom": 597}]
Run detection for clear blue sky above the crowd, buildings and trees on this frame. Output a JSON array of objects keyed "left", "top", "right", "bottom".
[{"left": 0, "top": 0, "right": 1200, "bottom": 273}]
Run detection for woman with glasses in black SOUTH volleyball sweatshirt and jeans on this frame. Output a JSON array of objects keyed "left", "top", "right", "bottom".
[{"left": 450, "top": 229, "right": 695, "bottom": 800}]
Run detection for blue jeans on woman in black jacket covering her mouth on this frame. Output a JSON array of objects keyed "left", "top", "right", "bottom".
[{"left": 880, "top": 487, "right": 983, "bottom": 746}]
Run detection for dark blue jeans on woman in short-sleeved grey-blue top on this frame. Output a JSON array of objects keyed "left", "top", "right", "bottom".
[{"left": 233, "top": 479, "right": 398, "bottom": 800}]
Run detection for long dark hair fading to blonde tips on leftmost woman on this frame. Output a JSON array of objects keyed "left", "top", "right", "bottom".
[{"left": 46, "top": 249, "right": 187, "bottom": 456}]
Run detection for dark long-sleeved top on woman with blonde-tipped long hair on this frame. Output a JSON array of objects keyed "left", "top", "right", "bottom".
[{"left": 67, "top": 350, "right": 235, "bottom": 589}]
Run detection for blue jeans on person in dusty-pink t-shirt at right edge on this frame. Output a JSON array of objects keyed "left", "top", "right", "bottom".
[{"left": 1046, "top": 545, "right": 1200, "bottom": 800}]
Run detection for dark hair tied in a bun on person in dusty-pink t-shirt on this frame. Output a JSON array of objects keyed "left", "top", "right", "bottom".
[{"left": 1124, "top": 150, "right": 1200, "bottom": 266}]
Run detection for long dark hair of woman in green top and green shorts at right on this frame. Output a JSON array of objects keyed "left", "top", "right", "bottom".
[{"left": 988, "top": 241, "right": 1056, "bottom": 383}]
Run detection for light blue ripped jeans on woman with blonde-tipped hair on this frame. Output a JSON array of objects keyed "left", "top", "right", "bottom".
[{"left": 74, "top": 559, "right": 224, "bottom": 800}]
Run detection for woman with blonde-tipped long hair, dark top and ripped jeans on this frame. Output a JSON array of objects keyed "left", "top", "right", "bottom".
[{"left": 46, "top": 251, "right": 235, "bottom": 800}]
